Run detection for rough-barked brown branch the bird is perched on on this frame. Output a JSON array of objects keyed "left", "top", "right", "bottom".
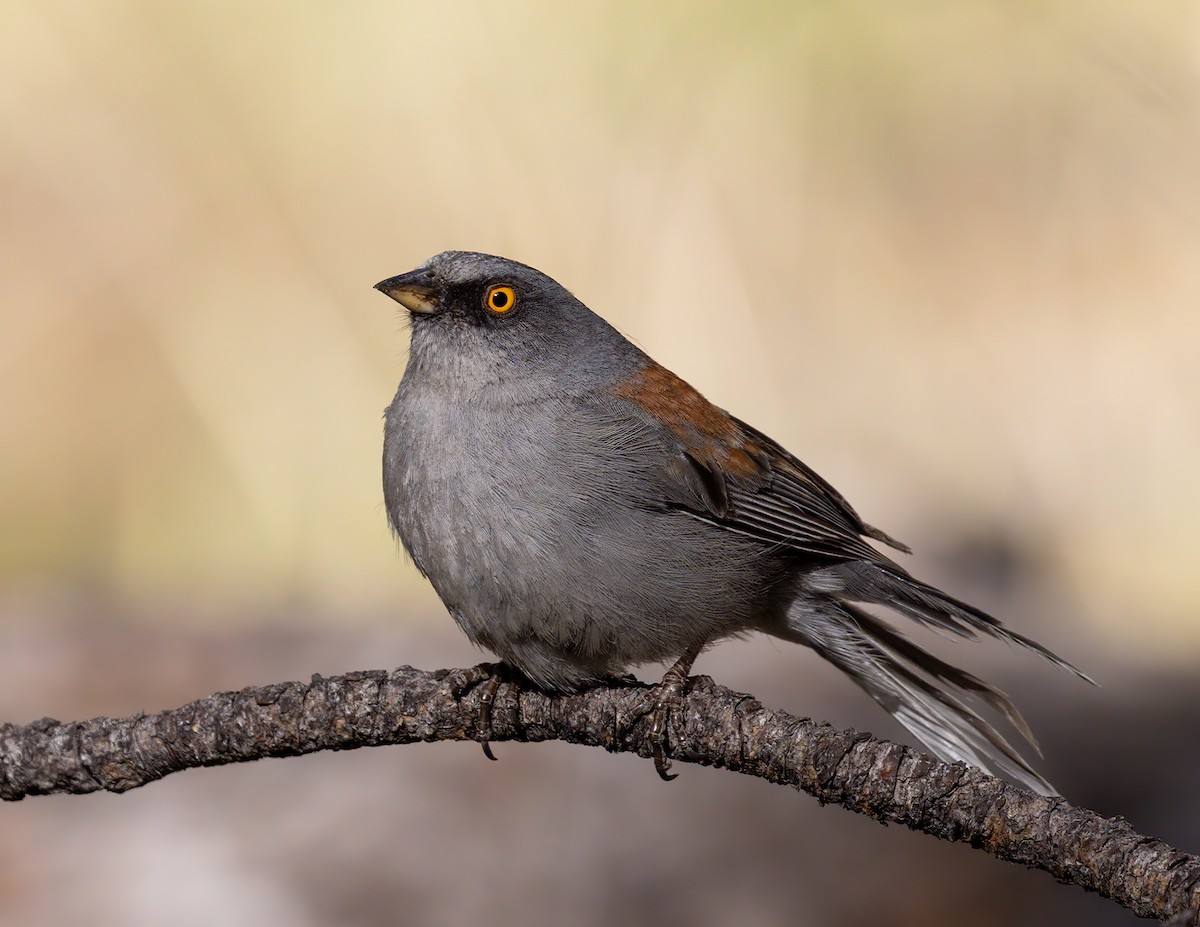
[{"left": 0, "top": 666, "right": 1200, "bottom": 923}]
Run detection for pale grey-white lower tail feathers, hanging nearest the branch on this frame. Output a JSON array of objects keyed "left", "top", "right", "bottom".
[{"left": 775, "top": 597, "right": 1065, "bottom": 795}]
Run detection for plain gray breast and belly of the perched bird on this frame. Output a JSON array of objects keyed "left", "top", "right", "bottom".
[{"left": 384, "top": 384, "right": 782, "bottom": 689}]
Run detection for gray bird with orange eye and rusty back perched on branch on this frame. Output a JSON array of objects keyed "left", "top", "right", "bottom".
[{"left": 376, "top": 251, "right": 1087, "bottom": 794}]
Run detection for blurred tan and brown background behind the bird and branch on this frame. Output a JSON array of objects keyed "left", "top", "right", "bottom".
[{"left": 0, "top": 0, "right": 1200, "bottom": 927}]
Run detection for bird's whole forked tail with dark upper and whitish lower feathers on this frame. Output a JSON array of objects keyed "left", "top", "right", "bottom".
[{"left": 774, "top": 563, "right": 1091, "bottom": 795}]
